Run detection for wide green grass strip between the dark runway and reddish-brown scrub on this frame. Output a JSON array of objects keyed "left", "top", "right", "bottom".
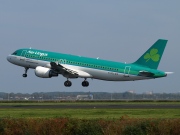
[{"left": 0, "top": 109, "right": 180, "bottom": 119}]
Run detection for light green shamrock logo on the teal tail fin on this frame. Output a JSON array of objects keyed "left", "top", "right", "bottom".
[{"left": 144, "top": 49, "right": 160, "bottom": 62}]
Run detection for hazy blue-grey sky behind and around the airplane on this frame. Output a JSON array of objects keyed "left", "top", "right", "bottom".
[{"left": 0, "top": 0, "right": 180, "bottom": 93}]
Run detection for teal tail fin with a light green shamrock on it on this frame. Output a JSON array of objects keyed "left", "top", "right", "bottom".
[{"left": 133, "top": 39, "right": 167, "bottom": 69}]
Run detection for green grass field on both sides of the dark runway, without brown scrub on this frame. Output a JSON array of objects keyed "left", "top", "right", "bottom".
[{"left": 0, "top": 102, "right": 180, "bottom": 119}]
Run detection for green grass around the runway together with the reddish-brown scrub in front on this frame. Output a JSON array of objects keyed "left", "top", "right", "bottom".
[{"left": 0, "top": 101, "right": 180, "bottom": 135}]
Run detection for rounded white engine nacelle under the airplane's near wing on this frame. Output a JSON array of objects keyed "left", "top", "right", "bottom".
[{"left": 35, "top": 66, "right": 58, "bottom": 78}]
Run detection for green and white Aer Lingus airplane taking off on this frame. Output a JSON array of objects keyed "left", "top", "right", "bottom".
[{"left": 7, "top": 39, "right": 172, "bottom": 87}]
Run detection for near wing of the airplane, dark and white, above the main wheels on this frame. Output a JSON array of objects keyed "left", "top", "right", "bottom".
[{"left": 50, "top": 62, "right": 92, "bottom": 78}]
